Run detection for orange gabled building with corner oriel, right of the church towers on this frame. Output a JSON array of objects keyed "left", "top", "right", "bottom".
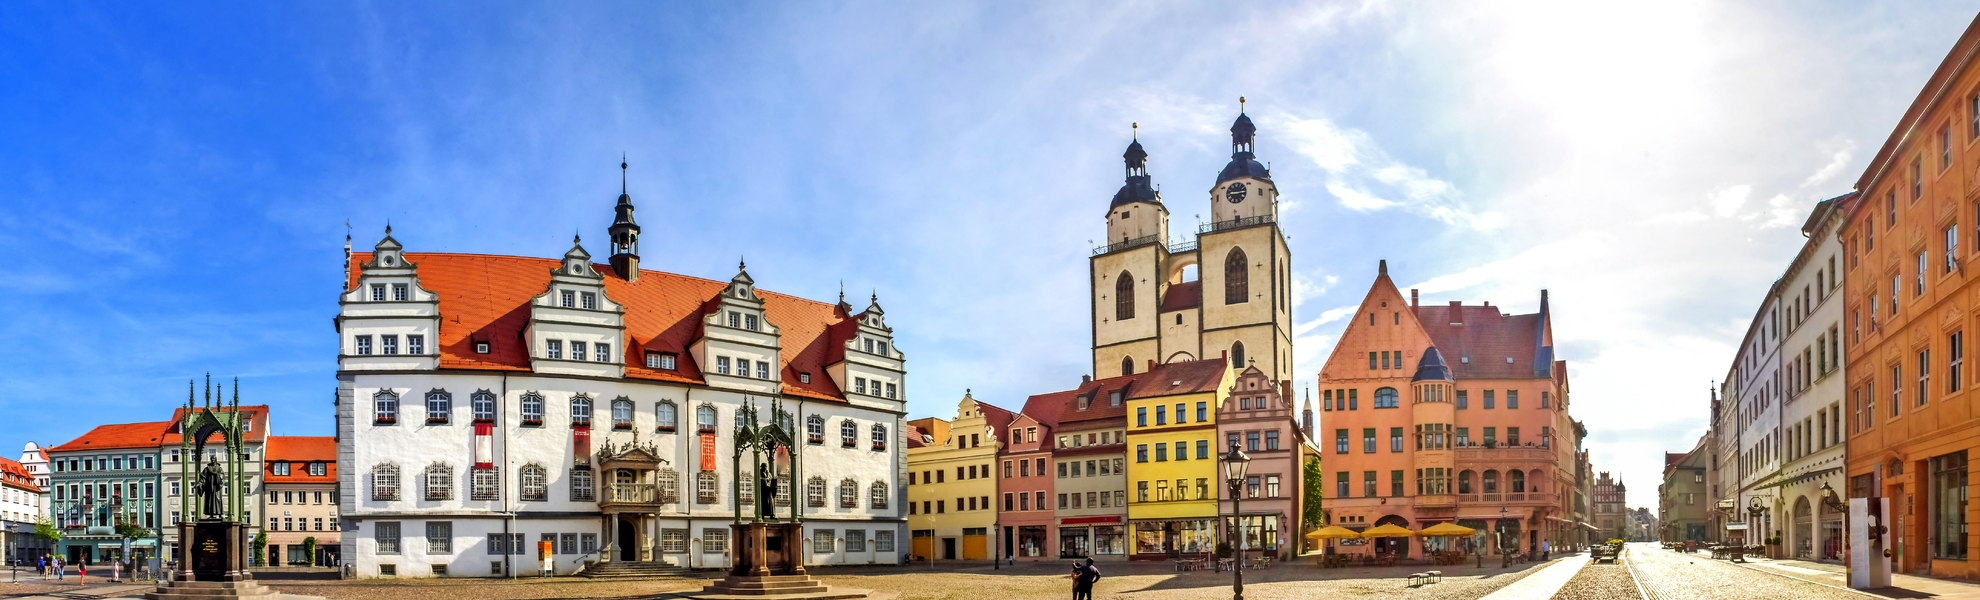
[{"left": 1313, "top": 261, "right": 1578, "bottom": 554}]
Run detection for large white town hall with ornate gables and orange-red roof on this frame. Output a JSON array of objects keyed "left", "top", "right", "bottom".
[{"left": 337, "top": 181, "right": 907, "bottom": 576}]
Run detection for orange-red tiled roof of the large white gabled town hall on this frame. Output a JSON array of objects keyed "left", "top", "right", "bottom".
[{"left": 348, "top": 251, "right": 855, "bottom": 400}]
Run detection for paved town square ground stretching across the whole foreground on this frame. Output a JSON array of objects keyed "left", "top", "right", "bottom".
[{"left": 11, "top": 543, "right": 1980, "bottom": 600}]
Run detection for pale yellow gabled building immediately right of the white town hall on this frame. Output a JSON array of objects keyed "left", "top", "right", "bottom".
[{"left": 907, "top": 392, "right": 1014, "bottom": 560}]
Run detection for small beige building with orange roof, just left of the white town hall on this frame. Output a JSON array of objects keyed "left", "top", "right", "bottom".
[{"left": 261, "top": 436, "right": 343, "bottom": 566}]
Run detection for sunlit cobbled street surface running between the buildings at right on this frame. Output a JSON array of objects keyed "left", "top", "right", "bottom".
[{"left": 1623, "top": 543, "right": 1863, "bottom": 600}]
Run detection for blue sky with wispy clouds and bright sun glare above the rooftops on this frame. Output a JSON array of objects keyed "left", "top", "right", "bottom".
[{"left": 0, "top": 2, "right": 1974, "bottom": 505}]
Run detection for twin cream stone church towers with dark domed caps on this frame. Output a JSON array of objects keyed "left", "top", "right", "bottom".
[{"left": 1089, "top": 99, "right": 1293, "bottom": 380}]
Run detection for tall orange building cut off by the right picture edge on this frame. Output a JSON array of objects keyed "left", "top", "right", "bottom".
[{"left": 1839, "top": 20, "right": 1980, "bottom": 578}]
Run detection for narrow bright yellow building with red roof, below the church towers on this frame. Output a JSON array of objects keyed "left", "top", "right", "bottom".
[{"left": 1124, "top": 358, "right": 1236, "bottom": 558}]
